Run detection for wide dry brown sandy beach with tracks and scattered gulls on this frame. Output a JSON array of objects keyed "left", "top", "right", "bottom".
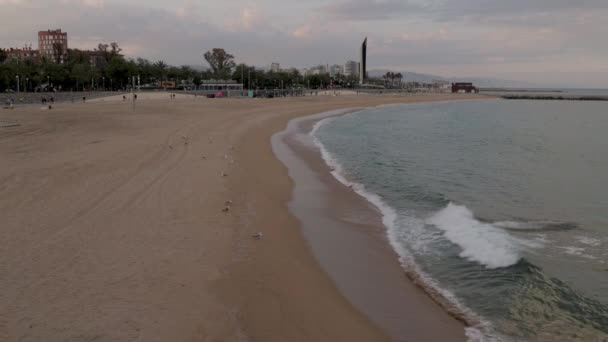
[{"left": 0, "top": 93, "right": 481, "bottom": 341}]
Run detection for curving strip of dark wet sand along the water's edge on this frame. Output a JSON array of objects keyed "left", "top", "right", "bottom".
[{"left": 272, "top": 104, "right": 472, "bottom": 341}]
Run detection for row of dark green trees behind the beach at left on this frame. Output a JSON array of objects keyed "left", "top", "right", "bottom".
[{"left": 0, "top": 43, "right": 394, "bottom": 92}]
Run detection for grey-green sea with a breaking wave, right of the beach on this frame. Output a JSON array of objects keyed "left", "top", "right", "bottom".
[{"left": 312, "top": 100, "right": 608, "bottom": 341}]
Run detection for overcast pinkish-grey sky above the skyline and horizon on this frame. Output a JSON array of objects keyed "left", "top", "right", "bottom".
[{"left": 0, "top": 0, "right": 608, "bottom": 88}]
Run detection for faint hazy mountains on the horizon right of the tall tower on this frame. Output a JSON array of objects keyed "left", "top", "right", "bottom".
[{"left": 367, "top": 69, "right": 538, "bottom": 88}]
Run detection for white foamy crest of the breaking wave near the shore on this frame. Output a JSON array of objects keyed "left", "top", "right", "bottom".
[{"left": 427, "top": 203, "right": 521, "bottom": 268}]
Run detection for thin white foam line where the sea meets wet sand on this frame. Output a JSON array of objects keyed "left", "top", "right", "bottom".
[{"left": 310, "top": 117, "right": 502, "bottom": 342}]
